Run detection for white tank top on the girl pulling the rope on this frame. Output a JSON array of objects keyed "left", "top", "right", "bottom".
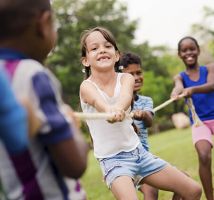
[{"left": 80, "top": 73, "right": 140, "bottom": 158}]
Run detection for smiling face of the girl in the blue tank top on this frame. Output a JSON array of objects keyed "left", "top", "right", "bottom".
[{"left": 178, "top": 38, "right": 200, "bottom": 67}]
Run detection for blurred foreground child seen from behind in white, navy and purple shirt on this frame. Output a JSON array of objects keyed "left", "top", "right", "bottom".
[{"left": 0, "top": 0, "right": 88, "bottom": 200}]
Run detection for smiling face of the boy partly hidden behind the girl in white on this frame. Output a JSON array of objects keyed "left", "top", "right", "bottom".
[{"left": 123, "top": 64, "right": 143, "bottom": 92}]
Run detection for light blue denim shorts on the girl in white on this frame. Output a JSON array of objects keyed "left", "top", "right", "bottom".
[{"left": 98, "top": 144, "right": 168, "bottom": 188}]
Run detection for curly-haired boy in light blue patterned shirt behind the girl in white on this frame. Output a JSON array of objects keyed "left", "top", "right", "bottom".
[{"left": 119, "top": 53, "right": 158, "bottom": 200}]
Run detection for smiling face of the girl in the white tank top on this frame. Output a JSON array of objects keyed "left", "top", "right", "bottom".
[{"left": 82, "top": 31, "right": 119, "bottom": 71}]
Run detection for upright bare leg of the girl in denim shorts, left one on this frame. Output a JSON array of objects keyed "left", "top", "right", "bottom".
[{"left": 111, "top": 176, "right": 138, "bottom": 200}]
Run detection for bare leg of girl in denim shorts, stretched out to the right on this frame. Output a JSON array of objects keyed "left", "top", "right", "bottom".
[{"left": 144, "top": 165, "right": 201, "bottom": 200}]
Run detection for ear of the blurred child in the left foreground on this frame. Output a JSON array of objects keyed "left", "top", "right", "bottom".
[{"left": 36, "top": 11, "right": 53, "bottom": 38}]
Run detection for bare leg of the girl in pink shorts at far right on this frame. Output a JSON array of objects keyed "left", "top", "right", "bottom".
[{"left": 195, "top": 140, "right": 214, "bottom": 200}]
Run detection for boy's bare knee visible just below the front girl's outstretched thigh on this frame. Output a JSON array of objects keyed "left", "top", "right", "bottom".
[{"left": 139, "top": 183, "right": 158, "bottom": 200}]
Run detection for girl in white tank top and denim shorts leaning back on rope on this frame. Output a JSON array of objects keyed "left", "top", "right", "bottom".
[{"left": 80, "top": 27, "right": 201, "bottom": 200}]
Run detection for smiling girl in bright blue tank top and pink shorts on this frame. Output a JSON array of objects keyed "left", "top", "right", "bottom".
[{"left": 171, "top": 36, "right": 214, "bottom": 200}]
